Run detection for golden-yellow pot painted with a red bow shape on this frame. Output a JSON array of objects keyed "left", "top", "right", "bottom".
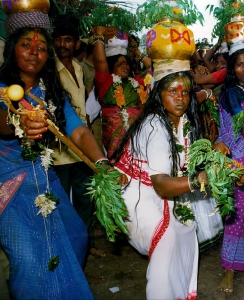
[{"left": 146, "top": 18, "right": 196, "bottom": 60}]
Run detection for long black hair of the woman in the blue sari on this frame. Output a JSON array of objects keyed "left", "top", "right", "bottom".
[{"left": 0, "top": 27, "right": 68, "bottom": 132}]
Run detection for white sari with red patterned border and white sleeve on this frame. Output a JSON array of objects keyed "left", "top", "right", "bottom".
[{"left": 116, "top": 117, "right": 198, "bottom": 300}]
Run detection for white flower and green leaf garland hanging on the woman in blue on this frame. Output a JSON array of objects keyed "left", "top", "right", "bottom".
[{"left": 9, "top": 79, "right": 59, "bottom": 271}]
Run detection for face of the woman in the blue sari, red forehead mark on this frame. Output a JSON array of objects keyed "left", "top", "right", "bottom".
[{"left": 15, "top": 30, "right": 48, "bottom": 76}]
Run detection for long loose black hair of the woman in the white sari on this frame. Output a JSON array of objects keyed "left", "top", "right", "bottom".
[{"left": 112, "top": 71, "right": 201, "bottom": 176}]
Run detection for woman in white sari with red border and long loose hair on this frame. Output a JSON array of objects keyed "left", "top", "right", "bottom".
[{"left": 113, "top": 63, "right": 231, "bottom": 299}]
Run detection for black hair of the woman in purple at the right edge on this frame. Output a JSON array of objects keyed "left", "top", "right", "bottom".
[{"left": 221, "top": 48, "right": 244, "bottom": 92}]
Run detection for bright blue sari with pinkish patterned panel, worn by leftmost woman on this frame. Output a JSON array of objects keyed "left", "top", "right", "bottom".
[{"left": 0, "top": 84, "right": 93, "bottom": 300}]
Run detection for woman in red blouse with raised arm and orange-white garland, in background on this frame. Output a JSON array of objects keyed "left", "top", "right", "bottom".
[{"left": 92, "top": 26, "right": 151, "bottom": 158}]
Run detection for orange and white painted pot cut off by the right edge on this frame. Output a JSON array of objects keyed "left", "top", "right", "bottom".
[{"left": 225, "top": 14, "right": 244, "bottom": 45}]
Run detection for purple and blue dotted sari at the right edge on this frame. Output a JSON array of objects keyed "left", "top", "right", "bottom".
[{"left": 219, "top": 87, "right": 244, "bottom": 271}]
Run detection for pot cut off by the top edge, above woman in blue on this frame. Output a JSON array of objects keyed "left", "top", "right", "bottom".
[{"left": 1, "top": 0, "right": 50, "bottom": 14}]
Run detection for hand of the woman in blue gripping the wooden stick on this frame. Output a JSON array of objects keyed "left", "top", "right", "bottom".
[{"left": 20, "top": 114, "right": 48, "bottom": 140}]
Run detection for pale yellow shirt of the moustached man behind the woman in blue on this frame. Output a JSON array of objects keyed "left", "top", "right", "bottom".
[{"left": 51, "top": 57, "right": 86, "bottom": 166}]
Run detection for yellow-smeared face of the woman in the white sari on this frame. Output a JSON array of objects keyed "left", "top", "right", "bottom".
[{"left": 161, "top": 77, "right": 190, "bottom": 124}]
